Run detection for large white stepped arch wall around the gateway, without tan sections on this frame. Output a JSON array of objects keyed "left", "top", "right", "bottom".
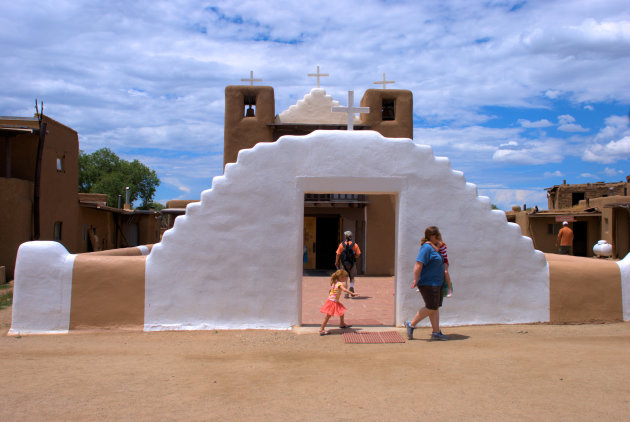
[{"left": 145, "top": 131, "right": 549, "bottom": 330}]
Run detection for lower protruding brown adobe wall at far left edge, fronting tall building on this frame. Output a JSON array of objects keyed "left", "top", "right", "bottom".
[{"left": 0, "top": 177, "right": 33, "bottom": 280}]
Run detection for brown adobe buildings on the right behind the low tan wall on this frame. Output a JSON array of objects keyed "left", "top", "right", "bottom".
[{"left": 506, "top": 176, "right": 630, "bottom": 259}]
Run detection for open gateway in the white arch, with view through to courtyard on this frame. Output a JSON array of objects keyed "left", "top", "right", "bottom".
[{"left": 301, "top": 193, "right": 398, "bottom": 328}]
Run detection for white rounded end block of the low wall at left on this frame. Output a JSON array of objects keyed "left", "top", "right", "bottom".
[{"left": 9, "top": 241, "right": 76, "bottom": 335}]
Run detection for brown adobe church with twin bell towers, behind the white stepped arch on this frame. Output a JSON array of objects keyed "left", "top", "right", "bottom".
[{"left": 223, "top": 85, "right": 413, "bottom": 275}]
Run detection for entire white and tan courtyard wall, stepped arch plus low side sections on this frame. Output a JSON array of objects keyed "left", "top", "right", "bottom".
[{"left": 11, "top": 131, "right": 630, "bottom": 333}]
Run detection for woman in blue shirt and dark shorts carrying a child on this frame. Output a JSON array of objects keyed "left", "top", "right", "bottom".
[{"left": 405, "top": 226, "right": 449, "bottom": 340}]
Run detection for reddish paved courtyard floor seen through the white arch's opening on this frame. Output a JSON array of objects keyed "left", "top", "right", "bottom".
[{"left": 302, "top": 276, "right": 394, "bottom": 328}]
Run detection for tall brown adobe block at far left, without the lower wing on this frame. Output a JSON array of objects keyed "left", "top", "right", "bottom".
[{"left": 0, "top": 114, "right": 79, "bottom": 282}]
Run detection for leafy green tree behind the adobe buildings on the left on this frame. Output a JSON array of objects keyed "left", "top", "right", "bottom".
[{"left": 79, "top": 148, "right": 160, "bottom": 209}]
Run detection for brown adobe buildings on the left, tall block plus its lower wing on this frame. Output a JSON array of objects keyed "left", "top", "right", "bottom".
[{"left": 0, "top": 114, "right": 160, "bottom": 283}]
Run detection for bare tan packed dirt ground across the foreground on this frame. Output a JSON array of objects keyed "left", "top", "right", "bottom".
[{"left": 0, "top": 309, "right": 630, "bottom": 422}]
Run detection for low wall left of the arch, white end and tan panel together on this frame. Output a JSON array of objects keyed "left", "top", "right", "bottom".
[{"left": 9, "top": 241, "right": 149, "bottom": 335}]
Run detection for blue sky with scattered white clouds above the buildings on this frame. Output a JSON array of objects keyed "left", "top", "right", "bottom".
[{"left": 0, "top": 0, "right": 630, "bottom": 210}]
